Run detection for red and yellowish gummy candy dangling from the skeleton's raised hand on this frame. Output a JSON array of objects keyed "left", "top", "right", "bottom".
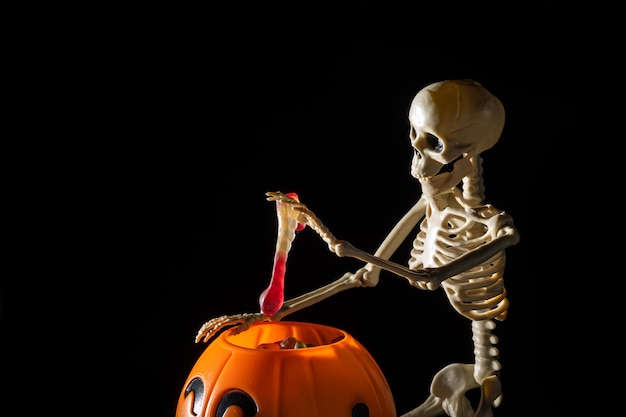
[{"left": 259, "top": 193, "right": 306, "bottom": 316}]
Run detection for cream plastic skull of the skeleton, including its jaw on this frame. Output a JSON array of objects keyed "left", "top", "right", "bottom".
[{"left": 409, "top": 80, "right": 504, "bottom": 196}]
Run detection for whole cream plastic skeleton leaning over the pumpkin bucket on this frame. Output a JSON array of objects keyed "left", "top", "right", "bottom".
[{"left": 196, "top": 80, "right": 519, "bottom": 417}]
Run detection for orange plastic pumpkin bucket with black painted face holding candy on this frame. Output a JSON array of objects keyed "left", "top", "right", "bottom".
[{"left": 176, "top": 322, "right": 396, "bottom": 417}]
